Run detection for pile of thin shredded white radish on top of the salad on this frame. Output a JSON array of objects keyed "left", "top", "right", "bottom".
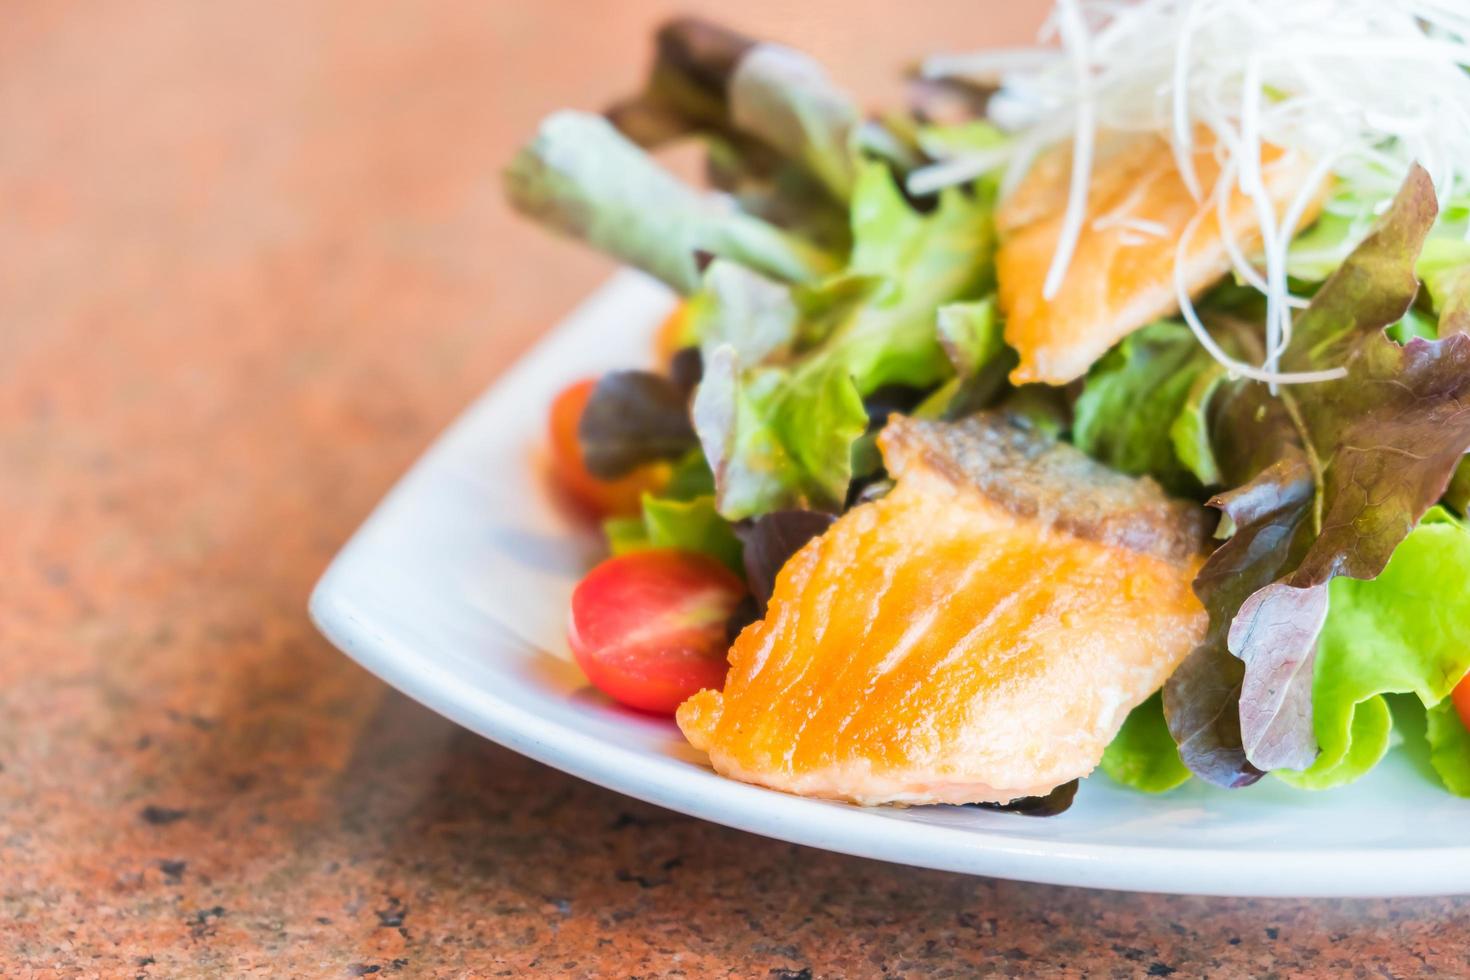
[{"left": 910, "top": 0, "right": 1470, "bottom": 386}]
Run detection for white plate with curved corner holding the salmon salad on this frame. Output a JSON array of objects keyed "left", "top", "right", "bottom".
[{"left": 312, "top": 273, "right": 1470, "bottom": 896}]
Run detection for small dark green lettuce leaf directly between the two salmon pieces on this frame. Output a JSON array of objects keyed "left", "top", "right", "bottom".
[{"left": 1072, "top": 320, "right": 1223, "bottom": 494}]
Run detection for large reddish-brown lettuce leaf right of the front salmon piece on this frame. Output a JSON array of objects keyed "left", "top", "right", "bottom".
[{"left": 1164, "top": 167, "right": 1470, "bottom": 786}]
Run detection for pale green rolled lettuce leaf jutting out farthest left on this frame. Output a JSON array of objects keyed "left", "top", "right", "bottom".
[{"left": 504, "top": 112, "right": 838, "bottom": 294}]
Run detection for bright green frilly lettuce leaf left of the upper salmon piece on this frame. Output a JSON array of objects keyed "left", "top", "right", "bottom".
[{"left": 694, "top": 162, "right": 994, "bottom": 520}]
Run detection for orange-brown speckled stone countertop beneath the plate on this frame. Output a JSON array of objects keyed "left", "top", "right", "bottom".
[{"left": 0, "top": 0, "right": 1470, "bottom": 977}]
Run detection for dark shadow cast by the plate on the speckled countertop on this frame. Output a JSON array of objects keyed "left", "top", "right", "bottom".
[{"left": 304, "top": 692, "right": 1470, "bottom": 976}]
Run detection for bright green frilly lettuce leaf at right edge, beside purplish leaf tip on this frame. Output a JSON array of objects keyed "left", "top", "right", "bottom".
[{"left": 1276, "top": 508, "right": 1470, "bottom": 789}]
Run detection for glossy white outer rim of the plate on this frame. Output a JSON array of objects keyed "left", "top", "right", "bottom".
[{"left": 309, "top": 269, "right": 1470, "bottom": 898}]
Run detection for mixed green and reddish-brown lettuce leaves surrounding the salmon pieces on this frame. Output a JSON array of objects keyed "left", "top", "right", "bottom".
[{"left": 506, "top": 19, "right": 1470, "bottom": 813}]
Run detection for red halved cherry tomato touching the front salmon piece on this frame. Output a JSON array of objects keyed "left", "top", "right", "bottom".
[{"left": 567, "top": 548, "right": 745, "bottom": 714}]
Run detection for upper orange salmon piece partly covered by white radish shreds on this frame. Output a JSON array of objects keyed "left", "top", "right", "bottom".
[{"left": 995, "top": 134, "right": 1326, "bottom": 385}]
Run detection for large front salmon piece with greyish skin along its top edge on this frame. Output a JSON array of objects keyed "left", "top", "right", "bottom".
[{"left": 678, "top": 416, "right": 1207, "bottom": 804}]
